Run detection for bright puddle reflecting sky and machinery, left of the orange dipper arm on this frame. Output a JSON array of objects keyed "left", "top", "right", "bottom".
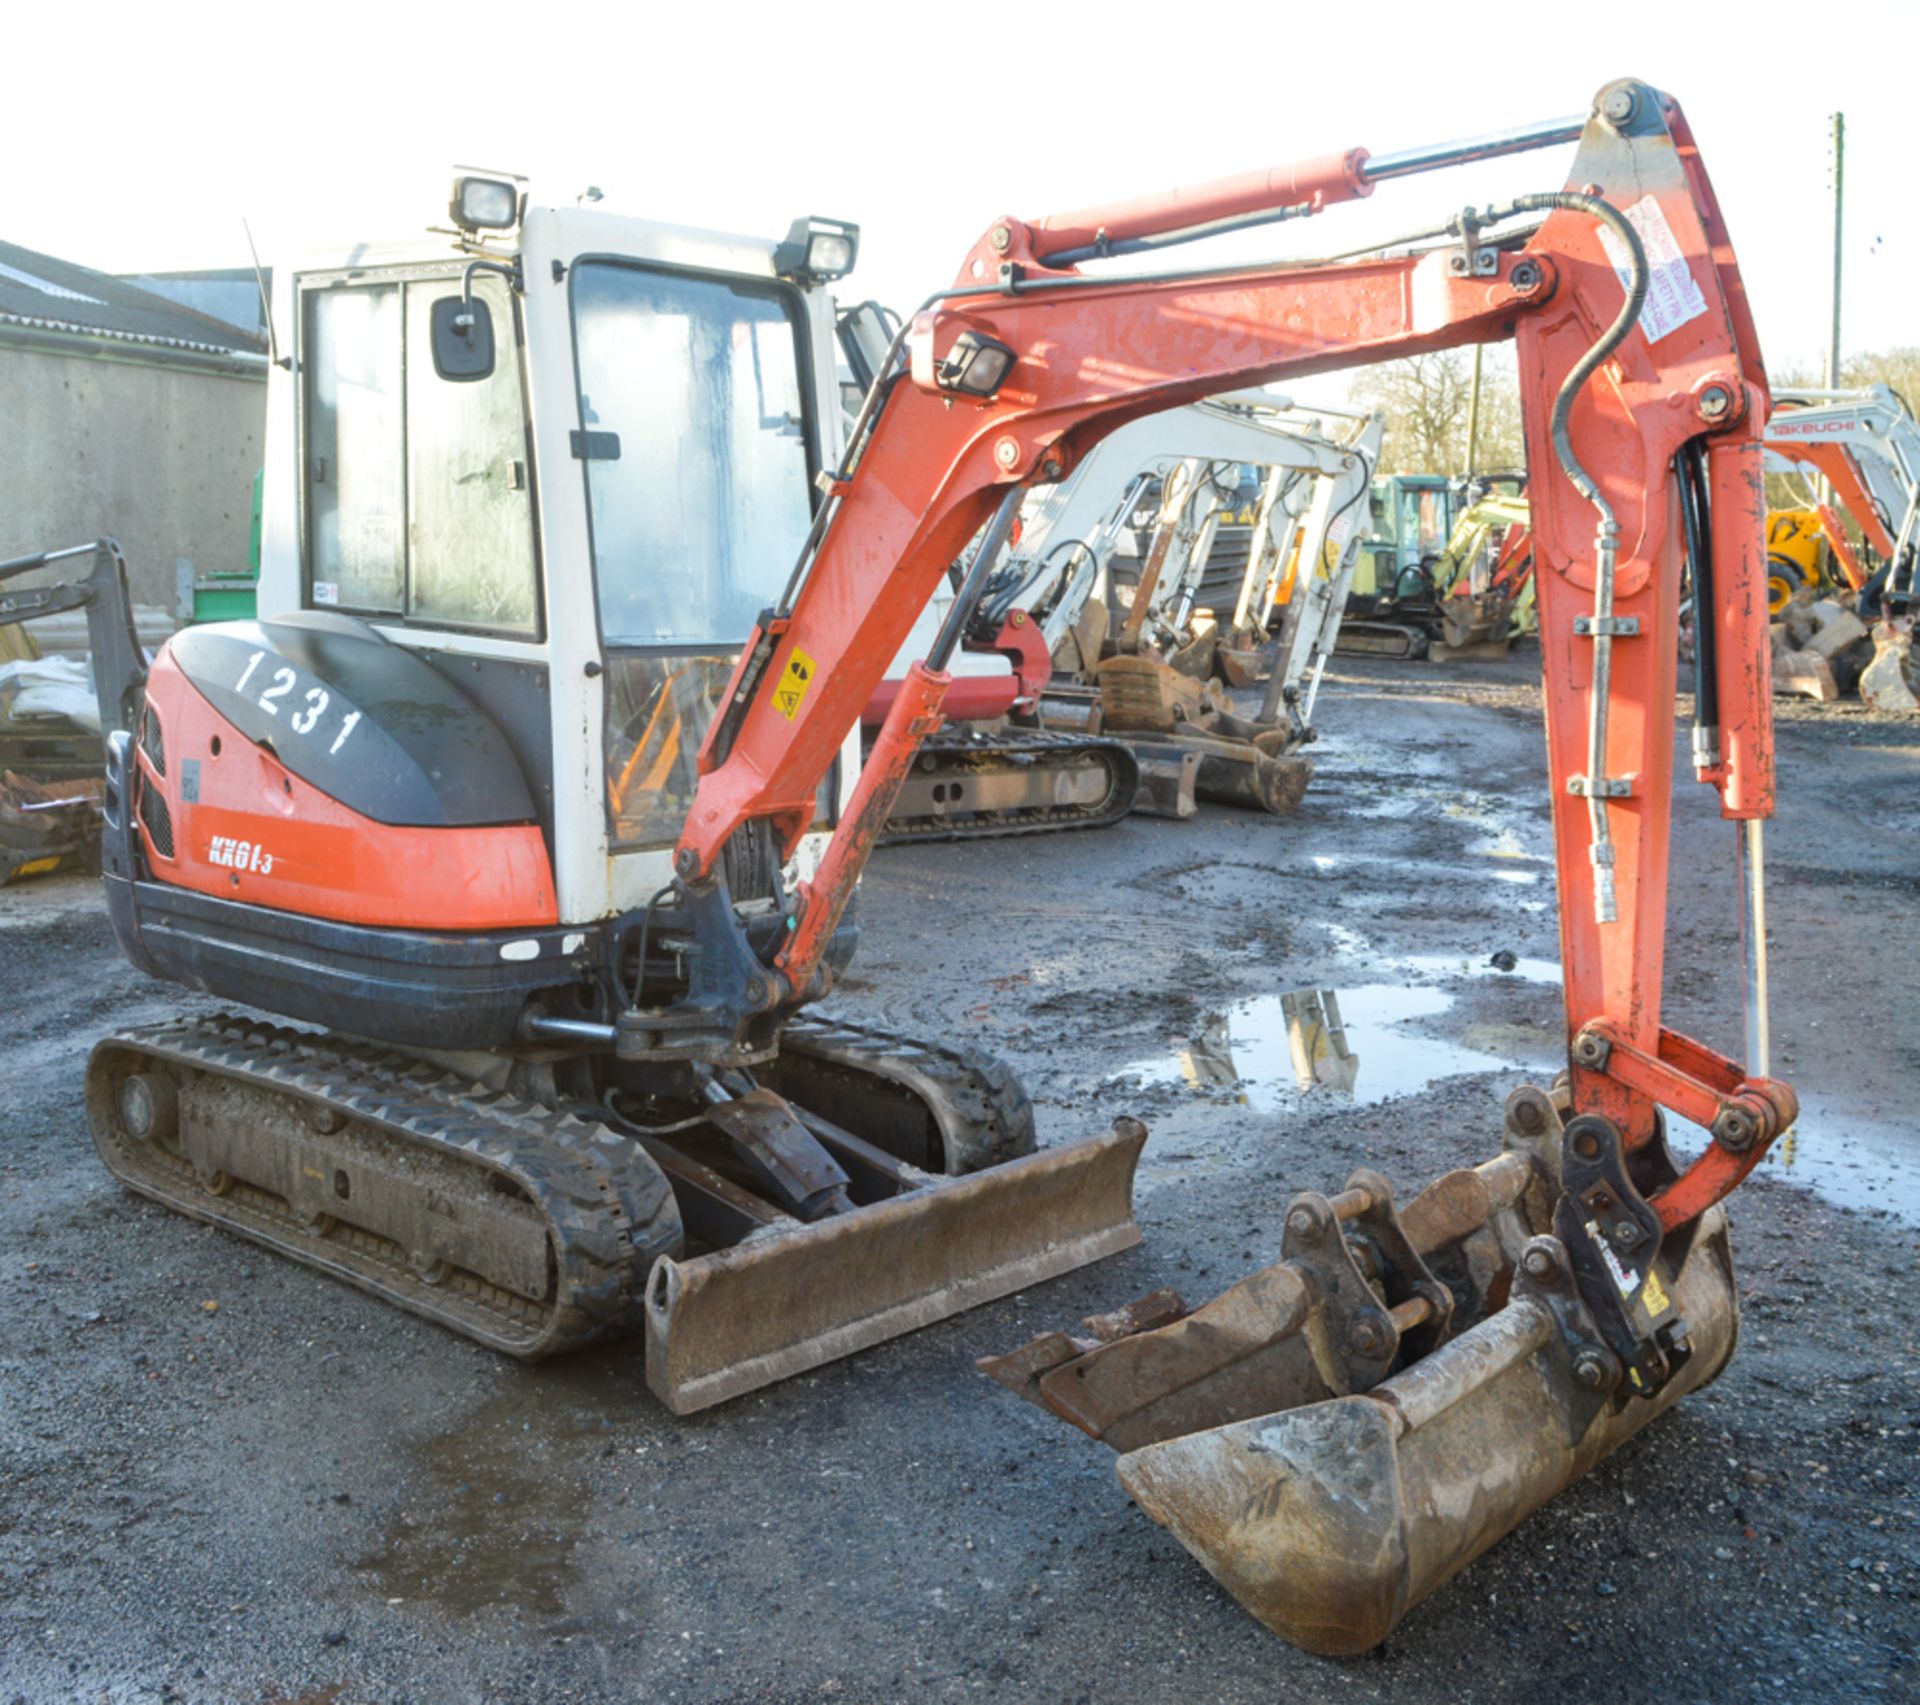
[{"left": 1116, "top": 983, "right": 1515, "bottom": 1112}]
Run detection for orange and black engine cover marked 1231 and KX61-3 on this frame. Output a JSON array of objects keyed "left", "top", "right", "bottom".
[{"left": 132, "top": 612, "right": 557, "bottom": 931}]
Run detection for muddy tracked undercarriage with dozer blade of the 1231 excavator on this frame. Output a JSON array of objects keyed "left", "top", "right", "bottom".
[{"left": 86, "top": 1016, "right": 1146, "bottom": 1413}]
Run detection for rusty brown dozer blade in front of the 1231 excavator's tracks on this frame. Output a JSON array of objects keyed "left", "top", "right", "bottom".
[{"left": 647, "top": 1119, "right": 1146, "bottom": 1415}]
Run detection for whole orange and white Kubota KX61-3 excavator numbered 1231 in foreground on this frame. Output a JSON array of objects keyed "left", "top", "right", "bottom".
[{"left": 7, "top": 81, "right": 1795, "bottom": 1653}]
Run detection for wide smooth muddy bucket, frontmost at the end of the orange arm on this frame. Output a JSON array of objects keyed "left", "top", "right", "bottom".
[{"left": 1119, "top": 1210, "right": 1738, "bottom": 1657}]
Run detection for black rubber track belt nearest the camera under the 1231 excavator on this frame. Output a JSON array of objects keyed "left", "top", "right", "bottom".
[{"left": 88, "top": 1016, "right": 680, "bottom": 1361}]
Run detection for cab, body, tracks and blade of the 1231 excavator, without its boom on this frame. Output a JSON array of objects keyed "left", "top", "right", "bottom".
[{"left": 41, "top": 179, "right": 1144, "bottom": 1411}]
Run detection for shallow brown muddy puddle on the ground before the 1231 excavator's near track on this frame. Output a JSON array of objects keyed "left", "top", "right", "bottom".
[{"left": 353, "top": 1384, "right": 601, "bottom": 1617}]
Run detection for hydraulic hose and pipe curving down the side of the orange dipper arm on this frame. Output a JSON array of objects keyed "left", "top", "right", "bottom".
[{"left": 1482, "top": 190, "right": 1649, "bottom": 924}]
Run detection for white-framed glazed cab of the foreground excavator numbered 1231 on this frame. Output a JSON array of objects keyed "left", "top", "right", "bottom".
[{"left": 261, "top": 207, "right": 852, "bottom": 918}]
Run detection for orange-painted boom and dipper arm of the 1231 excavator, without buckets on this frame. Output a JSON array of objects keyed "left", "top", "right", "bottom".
[{"left": 676, "top": 83, "right": 1789, "bottom": 1213}]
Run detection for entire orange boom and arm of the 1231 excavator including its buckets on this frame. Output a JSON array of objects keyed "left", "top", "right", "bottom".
[{"left": 637, "top": 83, "right": 1797, "bottom": 1653}]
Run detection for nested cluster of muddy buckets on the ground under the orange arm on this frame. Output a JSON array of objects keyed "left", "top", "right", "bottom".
[{"left": 981, "top": 1089, "right": 1738, "bottom": 1657}]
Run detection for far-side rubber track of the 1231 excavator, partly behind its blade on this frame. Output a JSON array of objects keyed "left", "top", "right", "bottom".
[{"left": 781, "top": 1014, "right": 1037, "bottom": 1173}]
